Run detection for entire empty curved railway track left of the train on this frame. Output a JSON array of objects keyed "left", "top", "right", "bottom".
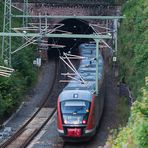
[{"left": 0, "top": 60, "right": 58, "bottom": 148}]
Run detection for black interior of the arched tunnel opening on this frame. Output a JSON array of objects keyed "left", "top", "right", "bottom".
[{"left": 48, "top": 19, "right": 94, "bottom": 56}]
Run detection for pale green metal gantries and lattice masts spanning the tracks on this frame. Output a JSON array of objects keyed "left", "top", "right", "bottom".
[{"left": 0, "top": 0, "right": 124, "bottom": 95}]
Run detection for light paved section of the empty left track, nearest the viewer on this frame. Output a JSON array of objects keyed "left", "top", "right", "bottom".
[{"left": 1, "top": 108, "right": 56, "bottom": 148}]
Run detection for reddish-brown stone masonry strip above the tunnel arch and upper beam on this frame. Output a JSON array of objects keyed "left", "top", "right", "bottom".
[{"left": 29, "top": 3, "right": 103, "bottom": 16}]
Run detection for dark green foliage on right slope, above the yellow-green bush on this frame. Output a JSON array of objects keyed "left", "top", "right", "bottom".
[{"left": 118, "top": 0, "right": 148, "bottom": 96}]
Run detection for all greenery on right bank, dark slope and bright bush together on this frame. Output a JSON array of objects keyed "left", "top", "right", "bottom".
[{"left": 108, "top": 0, "right": 148, "bottom": 148}]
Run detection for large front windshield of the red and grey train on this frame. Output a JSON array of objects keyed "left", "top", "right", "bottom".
[{"left": 61, "top": 101, "right": 90, "bottom": 125}]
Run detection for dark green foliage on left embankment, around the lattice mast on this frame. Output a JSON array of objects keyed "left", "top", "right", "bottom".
[{"left": 0, "top": 2, "right": 37, "bottom": 123}]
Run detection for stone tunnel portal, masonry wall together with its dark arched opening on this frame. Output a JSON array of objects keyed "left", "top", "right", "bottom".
[{"left": 15, "top": 0, "right": 114, "bottom": 56}]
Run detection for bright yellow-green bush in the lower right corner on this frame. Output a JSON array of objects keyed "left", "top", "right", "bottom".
[{"left": 108, "top": 87, "right": 148, "bottom": 148}]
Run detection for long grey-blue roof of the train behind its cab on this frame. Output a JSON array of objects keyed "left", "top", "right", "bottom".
[{"left": 61, "top": 44, "right": 104, "bottom": 101}]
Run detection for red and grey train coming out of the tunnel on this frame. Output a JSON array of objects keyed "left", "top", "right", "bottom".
[{"left": 57, "top": 44, "right": 104, "bottom": 141}]
